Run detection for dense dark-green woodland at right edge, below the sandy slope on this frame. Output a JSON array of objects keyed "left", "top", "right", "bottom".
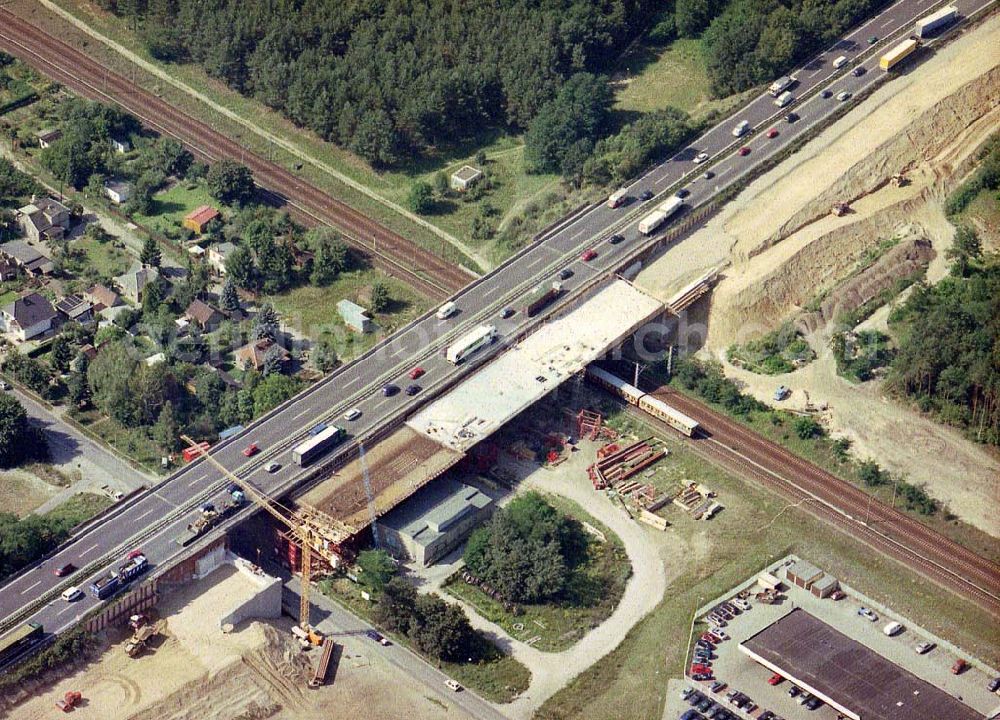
[{"left": 887, "top": 227, "right": 1000, "bottom": 445}]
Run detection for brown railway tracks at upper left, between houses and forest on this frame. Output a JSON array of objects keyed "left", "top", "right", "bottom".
[{"left": 0, "top": 8, "right": 472, "bottom": 300}]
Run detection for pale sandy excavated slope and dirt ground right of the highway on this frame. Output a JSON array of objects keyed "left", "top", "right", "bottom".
[{"left": 636, "top": 15, "right": 1000, "bottom": 536}]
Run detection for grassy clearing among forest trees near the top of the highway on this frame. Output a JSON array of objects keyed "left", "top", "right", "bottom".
[{"left": 615, "top": 38, "right": 742, "bottom": 118}]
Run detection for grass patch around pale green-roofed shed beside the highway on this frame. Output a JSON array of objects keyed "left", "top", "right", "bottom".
[{"left": 265, "top": 269, "right": 429, "bottom": 348}]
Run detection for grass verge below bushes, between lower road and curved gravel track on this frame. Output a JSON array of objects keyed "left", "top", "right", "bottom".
[{"left": 319, "top": 578, "right": 531, "bottom": 703}]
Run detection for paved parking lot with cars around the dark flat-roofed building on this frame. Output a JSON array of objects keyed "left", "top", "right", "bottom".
[{"left": 666, "top": 561, "right": 1000, "bottom": 720}]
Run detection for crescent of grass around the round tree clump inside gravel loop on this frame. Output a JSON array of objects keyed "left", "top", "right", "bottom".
[{"left": 445, "top": 495, "right": 632, "bottom": 652}]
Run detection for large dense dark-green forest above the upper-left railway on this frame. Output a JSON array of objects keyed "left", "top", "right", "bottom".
[{"left": 100, "top": 0, "right": 657, "bottom": 166}]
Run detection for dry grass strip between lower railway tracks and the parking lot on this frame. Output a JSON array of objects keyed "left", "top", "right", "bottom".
[{"left": 535, "top": 422, "right": 1000, "bottom": 720}]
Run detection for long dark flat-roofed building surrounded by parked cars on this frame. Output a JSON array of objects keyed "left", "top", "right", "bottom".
[{"left": 739, "top": 608, "right": 983, "bottom": 720}]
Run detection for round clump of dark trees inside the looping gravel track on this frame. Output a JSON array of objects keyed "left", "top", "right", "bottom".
[{"left": 464, "top": 492, "right": 588, "bottom": 603}]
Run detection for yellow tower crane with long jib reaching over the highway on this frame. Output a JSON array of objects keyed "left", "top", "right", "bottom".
[{"left": 181, "top": 435, "right": 353, "bottom": 634}]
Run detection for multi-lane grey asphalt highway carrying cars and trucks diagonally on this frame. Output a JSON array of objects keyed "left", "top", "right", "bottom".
[{"left": 0, "top": 0, "right": 990, "bottom": 652}]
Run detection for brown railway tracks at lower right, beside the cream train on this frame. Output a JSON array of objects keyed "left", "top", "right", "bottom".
[{"left": 616, "top": 388, "right": 1000, "bottom": 617}]
